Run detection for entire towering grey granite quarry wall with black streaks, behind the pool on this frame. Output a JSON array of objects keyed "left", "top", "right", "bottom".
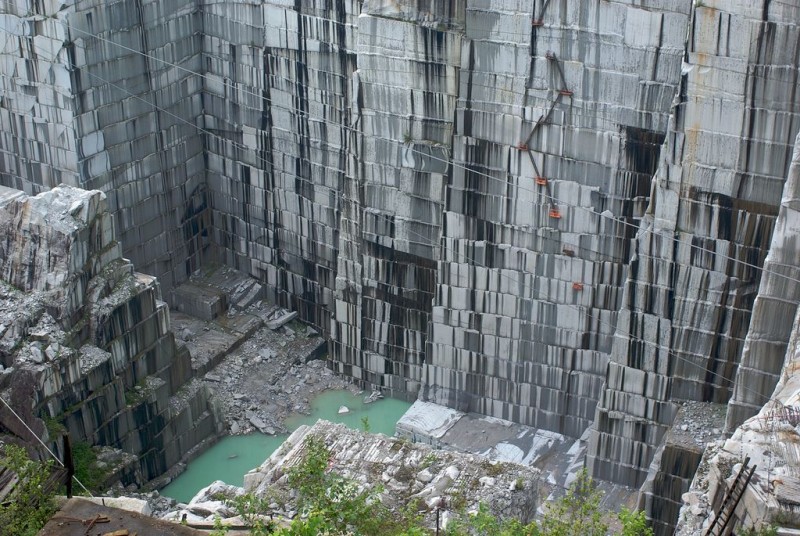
[{"left": 0, "top": 0, "right": 800, "bottom": 524}]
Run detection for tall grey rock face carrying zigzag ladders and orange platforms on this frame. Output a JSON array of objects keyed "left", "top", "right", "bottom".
[{"left": 425, "top": 1, "right": 689, "bottom": 436}]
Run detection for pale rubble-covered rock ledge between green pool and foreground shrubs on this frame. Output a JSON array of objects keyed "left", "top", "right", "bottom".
[{"left": 244, "top": 420, "right": 539, "bottom": 526}]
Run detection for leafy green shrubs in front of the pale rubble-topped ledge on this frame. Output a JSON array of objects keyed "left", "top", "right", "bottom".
[{"left": 222, "top": 438, "right": 653, "bottom": 536}]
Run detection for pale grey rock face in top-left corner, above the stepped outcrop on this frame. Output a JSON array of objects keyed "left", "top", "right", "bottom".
[{"left": 0, "top": 2, "right": 80, "bottom": 186}]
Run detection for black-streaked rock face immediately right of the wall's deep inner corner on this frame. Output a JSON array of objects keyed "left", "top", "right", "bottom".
[{"left": 206, "top": 0, "right": 358, "bottom": 332}]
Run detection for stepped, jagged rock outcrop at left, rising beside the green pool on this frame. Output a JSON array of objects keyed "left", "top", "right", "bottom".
[{"left": 0, "top": 186, "right": 220, "bottom": 484}]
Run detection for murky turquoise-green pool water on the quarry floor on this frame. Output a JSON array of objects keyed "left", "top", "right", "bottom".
[{"left": 160, "top": 391, "right": 411, "bottom": 502}]
